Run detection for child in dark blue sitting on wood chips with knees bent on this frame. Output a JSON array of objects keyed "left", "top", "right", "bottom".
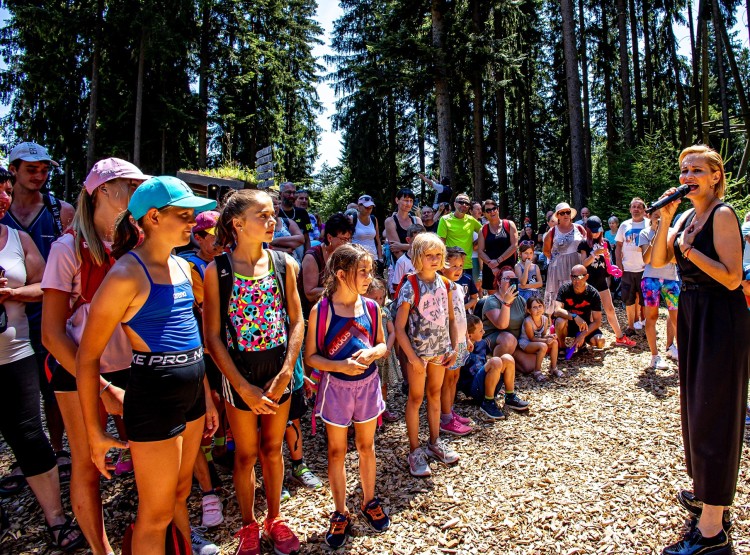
[{"left": 458, "top": 314, "right": 529, "bottom": 420}]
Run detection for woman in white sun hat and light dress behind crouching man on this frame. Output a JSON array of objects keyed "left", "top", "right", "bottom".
[{"left": 544, "top": 202, "right": 586, "bottom": 315}]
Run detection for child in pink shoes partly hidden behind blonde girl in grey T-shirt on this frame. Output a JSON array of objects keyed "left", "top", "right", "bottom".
[{"left": 440, "top": 247, "right": 474, "bottom": 436}]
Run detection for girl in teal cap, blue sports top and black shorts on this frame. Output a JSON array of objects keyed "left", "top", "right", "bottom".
[{"left": 79, "top": 176, "right": 217, "bottom": 555}]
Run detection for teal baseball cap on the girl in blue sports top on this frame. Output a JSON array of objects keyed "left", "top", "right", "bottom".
[{"left": 128, "top": 175, "right": 216, "bottom": 220}]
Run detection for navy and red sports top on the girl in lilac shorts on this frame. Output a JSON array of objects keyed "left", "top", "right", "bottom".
[{"left": 321, "top": 297, "right": 377, "bottom": 381}]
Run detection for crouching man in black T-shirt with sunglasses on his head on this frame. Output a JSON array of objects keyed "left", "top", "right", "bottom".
[{"left": 553, "top": 264, "right": 604, "bottom": 349}]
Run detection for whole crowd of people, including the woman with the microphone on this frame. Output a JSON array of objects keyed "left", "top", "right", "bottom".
[{"left": 0, "top": 142, "right": 750, "bottom": 555}]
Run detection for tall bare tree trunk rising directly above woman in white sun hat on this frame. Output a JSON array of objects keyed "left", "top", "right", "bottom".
[{"left": 560, "top": 0, "right": 588, "bottom": 210}]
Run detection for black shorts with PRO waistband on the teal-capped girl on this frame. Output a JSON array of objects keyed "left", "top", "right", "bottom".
[{"left": 123, "top": 347, "right": 206, "bottom": 441}]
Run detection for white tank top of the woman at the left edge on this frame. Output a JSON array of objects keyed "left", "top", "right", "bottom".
[{"left": 0, "top": 226, "right": 34, "bottom": 364}]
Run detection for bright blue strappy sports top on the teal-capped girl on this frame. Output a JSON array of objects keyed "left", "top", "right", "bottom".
[{"left": 125, "top": 252, "right": 201, "bottom": 353}]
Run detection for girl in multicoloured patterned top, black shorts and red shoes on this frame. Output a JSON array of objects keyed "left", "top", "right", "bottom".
[{"left": 203, "top": 189, "right": 304, "bottom": 555}]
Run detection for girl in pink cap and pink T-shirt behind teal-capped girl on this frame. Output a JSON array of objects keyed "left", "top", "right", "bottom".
[{"left": 42, "top": 158, "right": 147, "bottom": 555}]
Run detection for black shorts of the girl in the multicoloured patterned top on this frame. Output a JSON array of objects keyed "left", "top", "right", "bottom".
[{"left": 221, "top": 343, "right": 291, "bottom": 411}]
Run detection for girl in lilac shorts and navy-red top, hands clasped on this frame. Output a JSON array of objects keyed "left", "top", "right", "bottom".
[{"left": 305, "top": 244, "right": 390, "bottom": 549}]
